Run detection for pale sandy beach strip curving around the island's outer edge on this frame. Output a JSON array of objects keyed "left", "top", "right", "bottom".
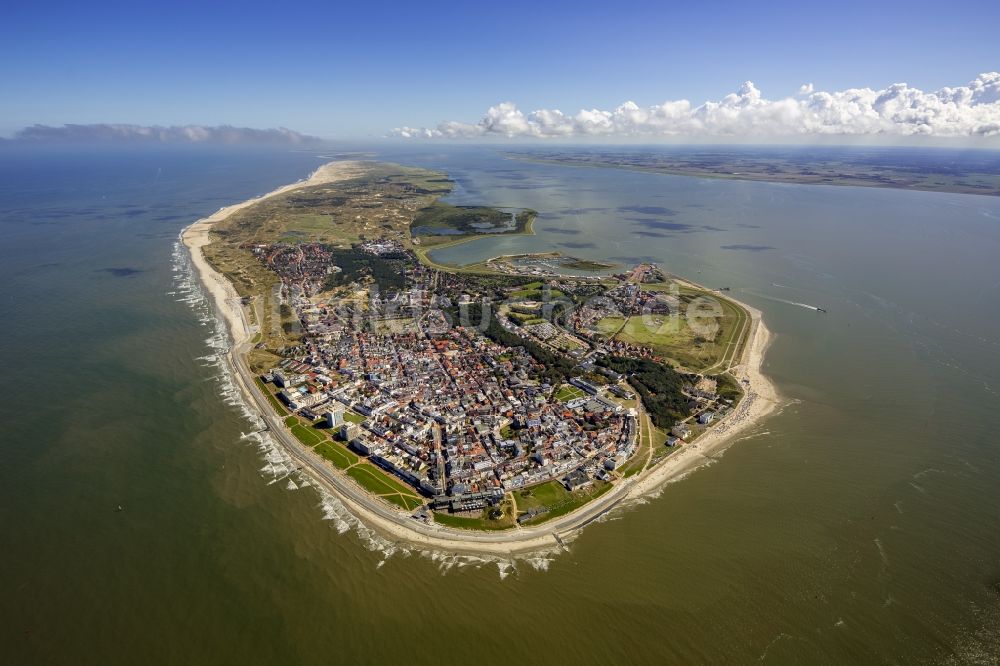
[{"left": 181, "top": 162, "right": 779, "bottom": 556}]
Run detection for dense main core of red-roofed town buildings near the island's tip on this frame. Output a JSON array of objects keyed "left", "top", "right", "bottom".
[{"left": 254, "top": 243, "right": 638, "bottom": 511}]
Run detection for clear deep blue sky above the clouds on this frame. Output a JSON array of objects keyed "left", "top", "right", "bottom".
[{"left": 0, "top": 1, "right": 1000, "bottom": 138}]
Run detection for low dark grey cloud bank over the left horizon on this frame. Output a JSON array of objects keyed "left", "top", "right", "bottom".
[{"left": 14, "top": 124, "right": 318, "bottom": 144}]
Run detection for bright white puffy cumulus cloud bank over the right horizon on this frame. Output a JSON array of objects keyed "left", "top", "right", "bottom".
[{"left": 391, "top": 72, "right": 1000, "bottom": 138}]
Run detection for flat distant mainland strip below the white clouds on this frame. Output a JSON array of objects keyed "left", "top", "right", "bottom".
[{"left": 508, "top": 146, "right": 1000, "bottom": 196}]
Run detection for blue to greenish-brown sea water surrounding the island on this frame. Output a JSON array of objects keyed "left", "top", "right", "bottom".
[{"left": 0, "top": 144, "right": 1000, "bottom": 664}]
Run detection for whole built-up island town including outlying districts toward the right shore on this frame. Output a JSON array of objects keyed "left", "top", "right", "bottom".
[{"left": 248, "top": 240, "right": 733, "bottom": 523}]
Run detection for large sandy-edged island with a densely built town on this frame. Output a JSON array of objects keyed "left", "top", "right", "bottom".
[{"left": 182, "top": 161, "right": 777, "bottom": 555}]
